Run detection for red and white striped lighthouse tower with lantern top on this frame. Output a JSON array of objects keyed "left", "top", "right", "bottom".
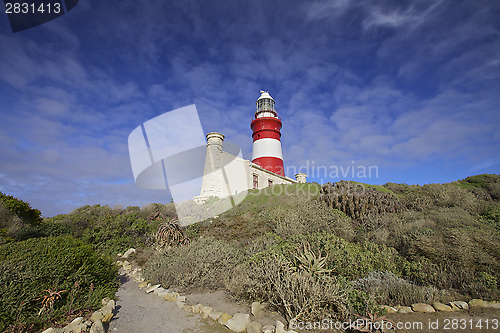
[{"left": 250, "top": 90, "right": 285, "bottom": 176}]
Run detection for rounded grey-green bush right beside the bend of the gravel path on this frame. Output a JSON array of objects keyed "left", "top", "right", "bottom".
[{"left": 144, "top": 238, "right": 240, "bottom": 290}]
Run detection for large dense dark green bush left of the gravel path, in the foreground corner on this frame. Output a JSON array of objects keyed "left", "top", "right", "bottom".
[{"left": 0, "top": 236, "right": 118, "bottom": 331}]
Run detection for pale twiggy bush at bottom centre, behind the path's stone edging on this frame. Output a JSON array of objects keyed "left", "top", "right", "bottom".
[{"left": 227, "top": 254, "right": 350, "bottom": 324}]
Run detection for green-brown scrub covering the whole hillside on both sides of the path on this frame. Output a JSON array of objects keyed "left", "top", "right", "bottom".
[{"left": 0, "top": 175, "right": 500, "bottom": 331}]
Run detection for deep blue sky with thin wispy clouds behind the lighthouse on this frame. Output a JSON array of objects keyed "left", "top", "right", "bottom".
[{"left": 0, "top": 0, "right": 500, "bottom": 216}]
